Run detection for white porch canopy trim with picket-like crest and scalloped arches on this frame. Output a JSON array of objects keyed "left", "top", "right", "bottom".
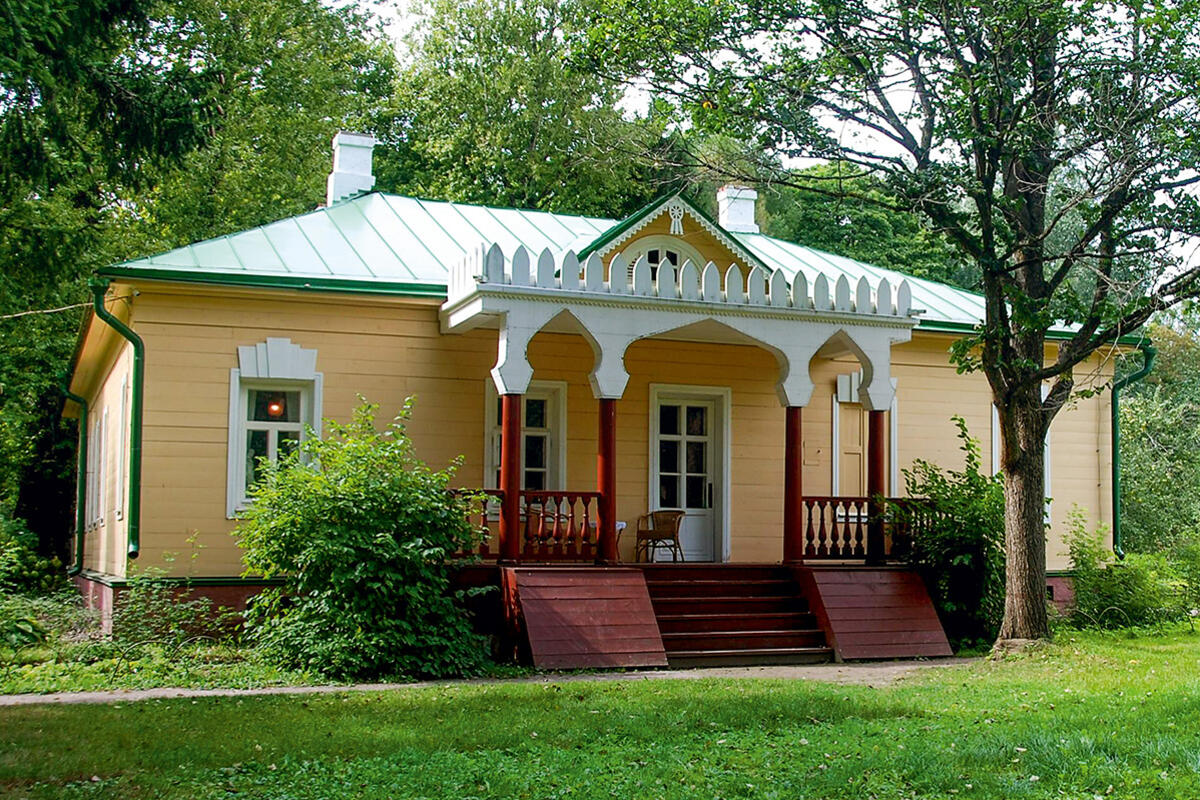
[{"left": 442, "top": 245, "right": 917, "bottom": 410}]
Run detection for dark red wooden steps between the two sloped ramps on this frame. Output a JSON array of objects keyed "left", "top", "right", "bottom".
[{"left": 642, "top": 564, "right": 833, "bottom": 667}]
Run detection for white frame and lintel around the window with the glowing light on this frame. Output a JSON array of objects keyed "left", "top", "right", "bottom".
[{"left": 226, "top": 338, "right": 324, "bottom": 519}]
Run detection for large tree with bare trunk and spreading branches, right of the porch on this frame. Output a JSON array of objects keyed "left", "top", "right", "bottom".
[{"left": 581, "top": 0, "right": 1200, "bottom": 644}]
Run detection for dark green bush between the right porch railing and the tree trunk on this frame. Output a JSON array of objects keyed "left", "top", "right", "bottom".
[{"left": 890, "top": 416, "right": 1004, "bottom": 648}]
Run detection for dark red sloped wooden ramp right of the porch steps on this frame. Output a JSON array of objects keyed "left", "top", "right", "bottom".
[{"left": 798, "top": 566, "right": 953, "bottom": 660}]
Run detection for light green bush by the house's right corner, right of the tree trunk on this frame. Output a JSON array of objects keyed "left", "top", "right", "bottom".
[{"left": 1067, "top": 510, "right": 1200, "bottom": 628}]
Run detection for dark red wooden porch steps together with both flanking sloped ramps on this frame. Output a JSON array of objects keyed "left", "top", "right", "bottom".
[{"left": 467, "top": 563, "right": 952, "bottom": 669}]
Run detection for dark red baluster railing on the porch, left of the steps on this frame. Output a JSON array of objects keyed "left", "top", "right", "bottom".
[{"left": 456, "top": 489, "right": 600, "bottom": 561}]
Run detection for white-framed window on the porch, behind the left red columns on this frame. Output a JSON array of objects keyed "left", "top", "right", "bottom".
[{"left": 484, "top": 381, "right": 566, "bottom": 492}]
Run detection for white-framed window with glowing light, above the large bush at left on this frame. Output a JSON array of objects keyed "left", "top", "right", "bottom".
[{"left": 226, "top": 338, "right": 322, "bottom": 518}]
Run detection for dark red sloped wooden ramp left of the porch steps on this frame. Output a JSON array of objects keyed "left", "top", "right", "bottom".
[{"left": 500, "top": 566, "right": 667, "bottom": 669}]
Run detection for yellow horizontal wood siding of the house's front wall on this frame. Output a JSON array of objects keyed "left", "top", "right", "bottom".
[{"left": 119, "top": 280, "right": 1111, "bottom": 576}]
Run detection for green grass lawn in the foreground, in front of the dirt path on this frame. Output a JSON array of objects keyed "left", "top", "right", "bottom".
[{"left": 0, "top": 632, "right": 1200, "bottom": 799}]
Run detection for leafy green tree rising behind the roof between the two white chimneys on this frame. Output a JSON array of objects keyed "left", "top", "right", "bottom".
[{"left": 374, "top": 0, "right": 671, "bottom": 216}]
